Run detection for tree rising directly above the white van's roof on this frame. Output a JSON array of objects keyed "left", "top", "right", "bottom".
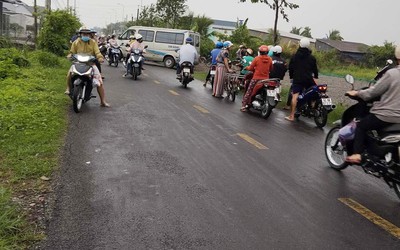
[{"left": 156, "top": 0, "right": 187, "bottom": 29}]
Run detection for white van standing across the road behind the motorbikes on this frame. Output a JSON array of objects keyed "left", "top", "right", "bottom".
[{"left": 118, "top": 26, "right": 200, "bottom": 68}]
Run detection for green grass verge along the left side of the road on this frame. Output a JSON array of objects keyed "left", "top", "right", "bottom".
[{"left": 0, "top": 51, "right": 69, "bottom": 249}]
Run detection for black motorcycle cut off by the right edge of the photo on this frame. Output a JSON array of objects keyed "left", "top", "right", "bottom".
[{"left": 325, "top": 62, "right": 400, "bottom": 199}]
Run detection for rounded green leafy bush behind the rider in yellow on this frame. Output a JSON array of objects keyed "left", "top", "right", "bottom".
[{"left": 38, "top": 10, "right": 81, "bottom": 56}]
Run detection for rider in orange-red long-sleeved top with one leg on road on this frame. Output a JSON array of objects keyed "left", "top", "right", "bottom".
[{"left": 240, "top": 45, "right": 272, "bottom": 112}]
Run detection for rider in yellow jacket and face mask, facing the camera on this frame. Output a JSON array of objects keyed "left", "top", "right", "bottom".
[{"left": 65, "top": 27, "right": 110, "bottom": 107}]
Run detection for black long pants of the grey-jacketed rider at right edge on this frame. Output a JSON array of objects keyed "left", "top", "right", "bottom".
[{"left": 353, "top": 114, "right": 392, "bottom": 154}]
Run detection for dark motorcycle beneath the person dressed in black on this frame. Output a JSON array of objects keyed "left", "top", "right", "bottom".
[{"left": 294, "top": 84, "right": 336, "bottom": 128}]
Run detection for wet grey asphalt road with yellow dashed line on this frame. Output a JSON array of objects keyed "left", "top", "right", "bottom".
[{"left": 43, "top": 62, "right": 400, "bottom": 249}]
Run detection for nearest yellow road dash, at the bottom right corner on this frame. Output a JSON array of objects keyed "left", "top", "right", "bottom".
[{"left": 338, "top": 198, "right": 400, "bottom": 239}]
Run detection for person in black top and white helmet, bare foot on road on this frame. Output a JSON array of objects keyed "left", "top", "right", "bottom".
[{"left": 285, "top": 38, "right": 318, "bottom": 121}]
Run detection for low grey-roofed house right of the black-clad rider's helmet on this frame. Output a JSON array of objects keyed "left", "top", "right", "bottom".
[{"left": 315, "top": 39, "right": 369, "bottom": 62}]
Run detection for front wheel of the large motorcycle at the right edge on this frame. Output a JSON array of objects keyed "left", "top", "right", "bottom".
[{"left": 325, "top": 126, "right": 348, "bottom": 170}]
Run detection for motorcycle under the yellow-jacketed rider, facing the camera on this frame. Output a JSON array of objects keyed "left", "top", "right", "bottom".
[{"left": 70, "top": 54, "right": 96, "bottom": 113}]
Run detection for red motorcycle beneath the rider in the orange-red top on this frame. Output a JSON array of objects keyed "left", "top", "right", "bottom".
[{"left": 248, "top": 78, "right": 281, "bottom": 119}]
